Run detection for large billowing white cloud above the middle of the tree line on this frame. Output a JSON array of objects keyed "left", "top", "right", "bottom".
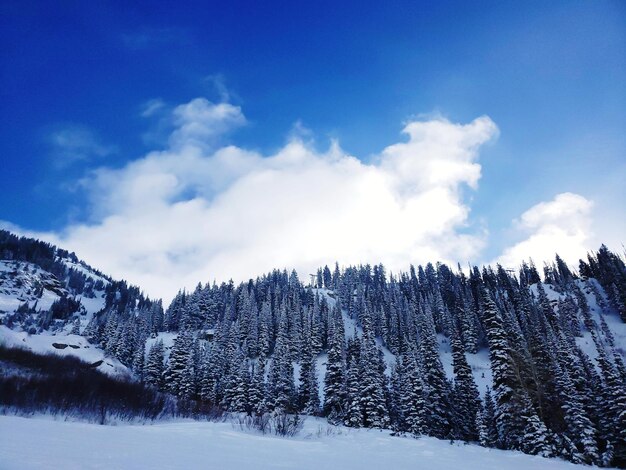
[{"left": 24, "top": 99, "right": 497, "bottom": 300}]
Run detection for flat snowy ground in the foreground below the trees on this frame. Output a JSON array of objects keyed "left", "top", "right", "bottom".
[{"left": 0, "top": 416, "right": 582, "bottom": 470}]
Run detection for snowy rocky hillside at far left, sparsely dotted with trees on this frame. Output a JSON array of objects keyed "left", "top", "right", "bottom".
[{"left": 0, "top": 230, "right": 160, "bottom": 377}]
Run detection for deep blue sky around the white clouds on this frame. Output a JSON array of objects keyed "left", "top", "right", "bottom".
[{"left": 0, "top": 1, "right": 626, "bottom": 298}]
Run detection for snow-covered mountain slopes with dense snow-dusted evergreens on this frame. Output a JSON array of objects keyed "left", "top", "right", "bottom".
[{"left": 0, "top": 232, "right": 626, "bottom": 466}]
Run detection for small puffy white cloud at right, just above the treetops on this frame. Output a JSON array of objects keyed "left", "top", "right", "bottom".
[{"left": 496, "top": 193, "right": 597, "bottom": 267}]
